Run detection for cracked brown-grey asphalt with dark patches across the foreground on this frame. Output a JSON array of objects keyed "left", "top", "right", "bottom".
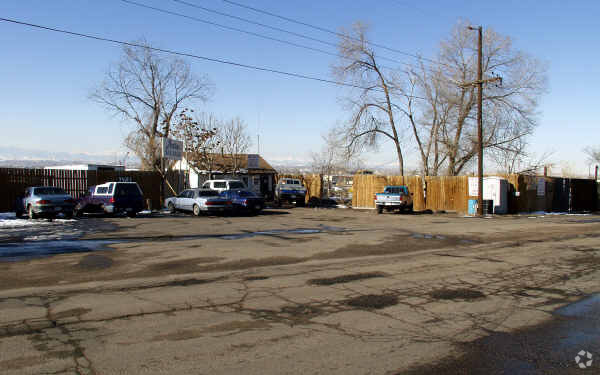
[{"left": 0, "top": 208, "right": 600, "bottom": 374}]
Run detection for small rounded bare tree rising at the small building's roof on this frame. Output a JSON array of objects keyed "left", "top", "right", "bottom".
[{"left": 218, "top": 117, "right": 252, "bottom": 175}]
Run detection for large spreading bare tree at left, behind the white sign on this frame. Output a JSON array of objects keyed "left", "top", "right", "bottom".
[{"left": 91, "top": 41, "right": 213, "bottom": 170}]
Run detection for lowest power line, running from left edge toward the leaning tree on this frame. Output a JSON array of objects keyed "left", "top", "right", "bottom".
[{"left": 0, "top": 17, "right": 427, "bottom": 100}]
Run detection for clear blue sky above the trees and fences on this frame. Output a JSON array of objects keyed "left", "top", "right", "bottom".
[{"left": 0, "top": 0, "right": 600, "bottom": 173}]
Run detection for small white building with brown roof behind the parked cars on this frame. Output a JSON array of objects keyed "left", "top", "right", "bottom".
[{"left": 173, "top": 154, "right": 277, "bottom": 199}]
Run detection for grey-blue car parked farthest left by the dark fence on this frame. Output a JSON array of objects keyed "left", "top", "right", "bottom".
[{"left": 15, "top": 186, "right": 75, "bottom": 219}]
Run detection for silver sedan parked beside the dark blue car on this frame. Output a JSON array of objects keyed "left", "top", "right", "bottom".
[{"left": 165, "top": 189, "right": 232, "bottom": 216}]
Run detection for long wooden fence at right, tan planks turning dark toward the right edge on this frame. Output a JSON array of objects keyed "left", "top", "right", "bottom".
[{"left": 352, "top": 175, "right": 598, "bottom": 213}]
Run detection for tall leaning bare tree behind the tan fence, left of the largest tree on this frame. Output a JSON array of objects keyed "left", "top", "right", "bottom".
[{"left": 333, "top": 23, "right": 404, "bottom": 176}]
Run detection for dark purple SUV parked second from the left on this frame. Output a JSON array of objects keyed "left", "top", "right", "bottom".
[{"left": 75, "top": 182, "right": 144, "bottom": 217}]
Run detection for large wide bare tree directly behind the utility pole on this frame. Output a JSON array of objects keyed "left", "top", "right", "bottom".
[{"left": 417, "top": 22, "right": 546, "bottom": 175}]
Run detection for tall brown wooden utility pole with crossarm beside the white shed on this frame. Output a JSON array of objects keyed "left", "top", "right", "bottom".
[{"left": 462, "top": 26, "right": 502, "bottom": 216}]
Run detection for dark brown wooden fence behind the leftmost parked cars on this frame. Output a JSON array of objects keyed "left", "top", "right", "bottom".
[{"left": 0, "top": 168, "right": 186, "bottom": 212}]
